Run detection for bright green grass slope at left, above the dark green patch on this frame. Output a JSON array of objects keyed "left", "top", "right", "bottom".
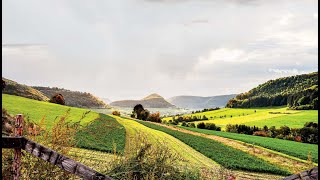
[{"left": 2, "top": 94, "right": 99, "bottom": 129}]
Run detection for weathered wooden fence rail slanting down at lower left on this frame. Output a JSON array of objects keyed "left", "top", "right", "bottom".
[{"left": 1, "top": 136, "right": 112, "bottom": 180}]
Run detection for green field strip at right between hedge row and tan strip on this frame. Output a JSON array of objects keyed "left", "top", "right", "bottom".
[{"left": 180, "top": 126, "right": 318, "bottom": 162}]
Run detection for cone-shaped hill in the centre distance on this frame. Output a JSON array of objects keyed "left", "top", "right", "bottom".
[{"left": 110, "top": 94, "right": 175, "bottom": 108}]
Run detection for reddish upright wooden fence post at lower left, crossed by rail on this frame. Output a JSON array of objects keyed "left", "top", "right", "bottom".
[{"left": 13, "top": 114, "right": 23, "bottom": 180}]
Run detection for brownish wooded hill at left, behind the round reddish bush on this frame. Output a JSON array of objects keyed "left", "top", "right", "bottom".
[{"left": 33, "top": 86, "right": 110, "bottom": 108}]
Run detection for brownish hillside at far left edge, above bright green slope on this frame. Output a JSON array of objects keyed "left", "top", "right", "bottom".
[{"left": 2, "top": 77, "right": 49, "bottom": 101}]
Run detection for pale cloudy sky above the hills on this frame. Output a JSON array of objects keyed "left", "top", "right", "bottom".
[{"left": 2, "top": 0, "right": 318, "bottom": 101}]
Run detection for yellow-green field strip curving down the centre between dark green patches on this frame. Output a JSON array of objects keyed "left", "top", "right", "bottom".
[{"left": 113, "top": 116, "right": 218, "bottom": 168}]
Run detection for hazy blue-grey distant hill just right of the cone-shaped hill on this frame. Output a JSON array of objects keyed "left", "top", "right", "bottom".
[{"left": 167, "top": 94, "right": 236, "bottom": 109}]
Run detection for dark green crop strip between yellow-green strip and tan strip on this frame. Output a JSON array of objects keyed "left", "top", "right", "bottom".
[{"left": 139, "top": 121, "right": 290, "bottom": 175}]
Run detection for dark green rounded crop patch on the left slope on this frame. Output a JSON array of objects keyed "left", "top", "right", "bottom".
[{"left": 76, "top": 114, "right": 126, "bottom": 153}]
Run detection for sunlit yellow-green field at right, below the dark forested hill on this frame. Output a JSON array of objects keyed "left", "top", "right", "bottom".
[{"left": 163, "top": 107, "right": 318, "bottom": 130}]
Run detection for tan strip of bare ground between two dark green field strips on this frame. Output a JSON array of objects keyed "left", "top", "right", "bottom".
[{"left": 154, "top": 123, "right": 309, "bottom": 174}]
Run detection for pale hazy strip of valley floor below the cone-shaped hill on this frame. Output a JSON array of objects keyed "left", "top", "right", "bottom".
[{"left": 91, "top": 107, "right": 199, "bottom": 116}]
